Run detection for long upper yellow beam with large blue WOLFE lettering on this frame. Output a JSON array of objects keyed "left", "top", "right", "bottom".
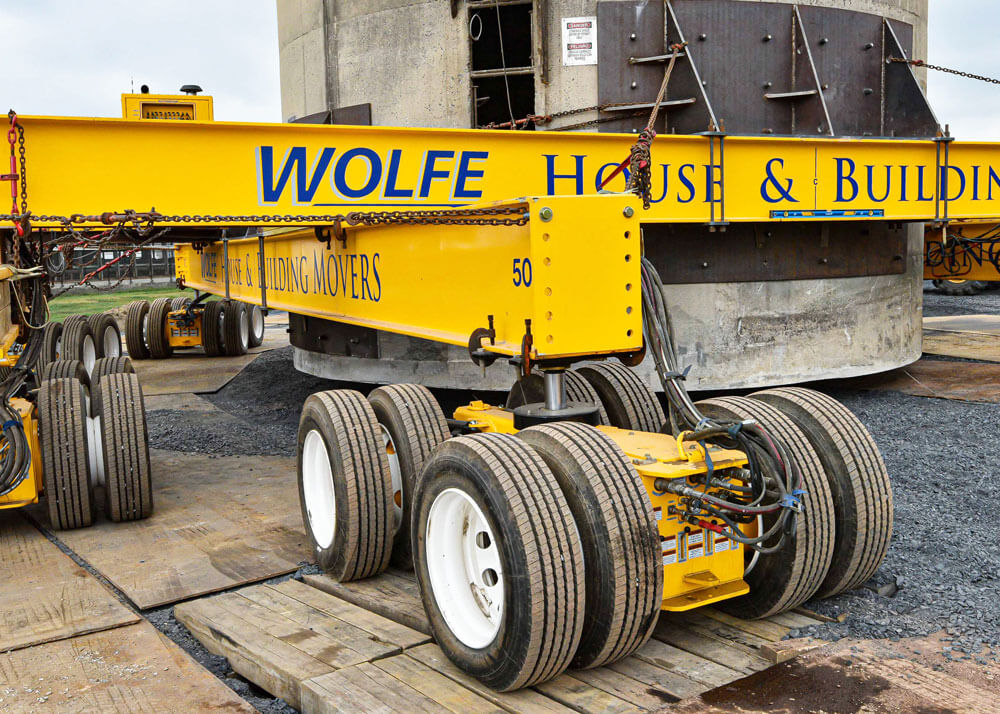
[{"left": 13, "top": 117, "right": 1000, "bottom": 225}]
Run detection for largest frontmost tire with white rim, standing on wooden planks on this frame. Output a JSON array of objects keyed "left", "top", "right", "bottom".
[{"left": 411, "top": 434, "right": 585, "bottom": 692}]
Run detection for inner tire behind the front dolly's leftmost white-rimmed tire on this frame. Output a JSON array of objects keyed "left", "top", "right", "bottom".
[{"left": 368, "top": 384, "right": 450, "bottom": 570}]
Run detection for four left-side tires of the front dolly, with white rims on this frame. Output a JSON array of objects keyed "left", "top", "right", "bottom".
[{"left": 298, "top": 385, "right": 663, "bottom": 691}]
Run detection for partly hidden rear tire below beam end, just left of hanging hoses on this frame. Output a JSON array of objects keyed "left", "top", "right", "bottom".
[{"left": 577, "top": 361, "right": 667, "bottom": 432}]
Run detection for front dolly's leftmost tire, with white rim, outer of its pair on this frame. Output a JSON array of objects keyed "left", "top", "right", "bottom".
[{"left": 297, "top": 390, "right": 393, "bottom": 582}]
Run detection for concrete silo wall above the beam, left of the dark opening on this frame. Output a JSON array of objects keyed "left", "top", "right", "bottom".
[{"left": 277, "top": 0, "right": 471, "bottom": 127}]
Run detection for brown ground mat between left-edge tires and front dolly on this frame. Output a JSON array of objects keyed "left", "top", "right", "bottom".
[{"left": 52, "top": 449, "right": 312, "bottom": 609}]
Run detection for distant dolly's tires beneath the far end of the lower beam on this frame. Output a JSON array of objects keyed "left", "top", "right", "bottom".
[{"left": 125, "top": 297, "right": 264, "bottom": 359}]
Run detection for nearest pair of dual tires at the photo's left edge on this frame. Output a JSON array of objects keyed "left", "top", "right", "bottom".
[{"left": 36, "top": 356, "right": 153, "bottom": 530}]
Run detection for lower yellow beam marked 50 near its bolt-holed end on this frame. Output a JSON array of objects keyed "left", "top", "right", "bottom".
[{"left": 176, "top": 195, "right": 642, "bottom": 359}]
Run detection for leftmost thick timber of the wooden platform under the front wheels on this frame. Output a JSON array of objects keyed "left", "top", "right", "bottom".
[{"left": 174, "top": 595, "right": 333, "bottom": 709}]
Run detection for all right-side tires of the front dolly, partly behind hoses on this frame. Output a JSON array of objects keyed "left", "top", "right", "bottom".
[{"left": 507, "top": 362, "right": 893, "bottom": 618}]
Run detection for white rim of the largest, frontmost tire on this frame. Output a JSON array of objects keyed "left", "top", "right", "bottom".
[{"left": 425, "top": 488, "right": 504, "bottom": 649}]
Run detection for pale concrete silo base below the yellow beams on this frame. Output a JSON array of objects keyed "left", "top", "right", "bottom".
[{"left": 294, "top": 225, "right": 923, "bottom": 391}]
